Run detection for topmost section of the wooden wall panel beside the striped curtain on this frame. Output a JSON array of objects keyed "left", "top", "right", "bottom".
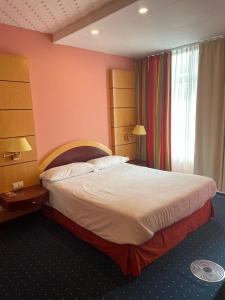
[{"left": 110, "top": 70, "right": 135, "bottom": 89}]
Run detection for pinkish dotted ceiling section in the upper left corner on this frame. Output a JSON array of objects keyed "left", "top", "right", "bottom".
[{"left": 0, "top": 0, "right": 112, "bottom": 33}]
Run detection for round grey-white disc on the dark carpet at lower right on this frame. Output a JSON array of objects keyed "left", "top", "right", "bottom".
[{"left": 190, "top": 260, "right": 225, "bottom": 282}]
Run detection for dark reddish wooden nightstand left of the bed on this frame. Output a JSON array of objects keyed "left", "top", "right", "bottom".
[{"left": 0, "top": 185, "right": 48, "bottom": 212}]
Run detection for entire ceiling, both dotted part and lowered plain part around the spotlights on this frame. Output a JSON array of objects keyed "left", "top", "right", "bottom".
[{"left": 0, "top": 0, "right": 225, "bottom": 58}]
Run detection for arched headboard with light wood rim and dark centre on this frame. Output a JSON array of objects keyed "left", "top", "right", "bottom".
[{"left": 39, "top": 141, "right": 112, "bottom": 172}]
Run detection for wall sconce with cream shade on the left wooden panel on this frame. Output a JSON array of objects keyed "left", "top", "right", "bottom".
[{"left": 3, "top": 137, "right": 32, "bottom": 160}]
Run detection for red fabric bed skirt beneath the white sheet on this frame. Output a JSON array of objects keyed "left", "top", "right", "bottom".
[{"left": 44, "top": 200, "right": 214, "bottom": 276}]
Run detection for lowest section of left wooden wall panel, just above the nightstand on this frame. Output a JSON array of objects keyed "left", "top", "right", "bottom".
[{"left": 0, "top": 161, "right": 39, "bottom": 193}]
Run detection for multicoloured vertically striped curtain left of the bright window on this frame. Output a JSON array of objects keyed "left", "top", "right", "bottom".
[{"left": 136, "top": 52, "right": 171, "bottom": 170}]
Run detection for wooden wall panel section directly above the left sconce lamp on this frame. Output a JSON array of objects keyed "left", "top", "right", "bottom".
[{"left": 0, "top": 110, "right": 34, "bottom": 138}]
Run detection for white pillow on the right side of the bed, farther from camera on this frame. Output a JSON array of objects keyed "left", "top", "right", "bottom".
[{"left": 88, "top": 155, "right": 129, "bottom": 170}]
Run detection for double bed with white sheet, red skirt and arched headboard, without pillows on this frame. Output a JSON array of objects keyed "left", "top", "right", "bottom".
[{"left": 39, "top": 141, "right": 216, "bottom": 276}]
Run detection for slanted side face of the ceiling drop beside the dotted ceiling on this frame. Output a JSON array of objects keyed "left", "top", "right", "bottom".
[{"left": 52, "top": 0, "right": 138, "bottom": 42}]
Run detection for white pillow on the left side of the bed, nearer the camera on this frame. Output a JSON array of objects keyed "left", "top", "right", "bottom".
[{"left": 40, "top": 162, "right": 95, "bottom": 182}]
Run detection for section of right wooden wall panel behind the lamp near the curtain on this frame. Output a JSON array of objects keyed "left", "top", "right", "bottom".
[{"left": 112, "top": 126, "right": 136, "bottom": 146}]
